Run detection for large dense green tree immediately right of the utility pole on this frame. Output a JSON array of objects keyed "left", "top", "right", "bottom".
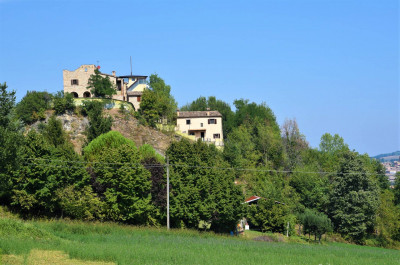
[{"left": 167, "top": 139, "right": 244, "bottom": 232}]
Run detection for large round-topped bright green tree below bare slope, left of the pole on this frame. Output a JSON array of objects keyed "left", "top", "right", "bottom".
[{"left": 84, "top": 131, "right": 157, "bottom": 225}]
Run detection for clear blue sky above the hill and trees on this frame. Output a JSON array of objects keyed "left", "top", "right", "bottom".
[{"left": 0, "top": 0, "right": 400, "bottom": 155}]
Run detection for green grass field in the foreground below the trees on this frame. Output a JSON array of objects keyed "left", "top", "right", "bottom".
[{"left": 0, "top": 214, "right": 400, "bottom": 265}]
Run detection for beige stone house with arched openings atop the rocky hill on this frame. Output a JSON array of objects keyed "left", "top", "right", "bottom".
[{"left": 63, "top": 64, "right": 147, "bottom": 110}]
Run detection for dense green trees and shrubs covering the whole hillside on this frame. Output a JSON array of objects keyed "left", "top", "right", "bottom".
[{"left": 0, "top": 79, "right": 400, "bottom": 248}]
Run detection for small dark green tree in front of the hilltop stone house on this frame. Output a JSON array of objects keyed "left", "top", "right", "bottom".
[{"left": 87, "top": 69, "right": 117, "bottom": 98}]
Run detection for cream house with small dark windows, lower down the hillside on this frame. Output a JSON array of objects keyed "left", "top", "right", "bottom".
[{"left": 175, "top": 110, "right": 224, "bottom": 146}]
